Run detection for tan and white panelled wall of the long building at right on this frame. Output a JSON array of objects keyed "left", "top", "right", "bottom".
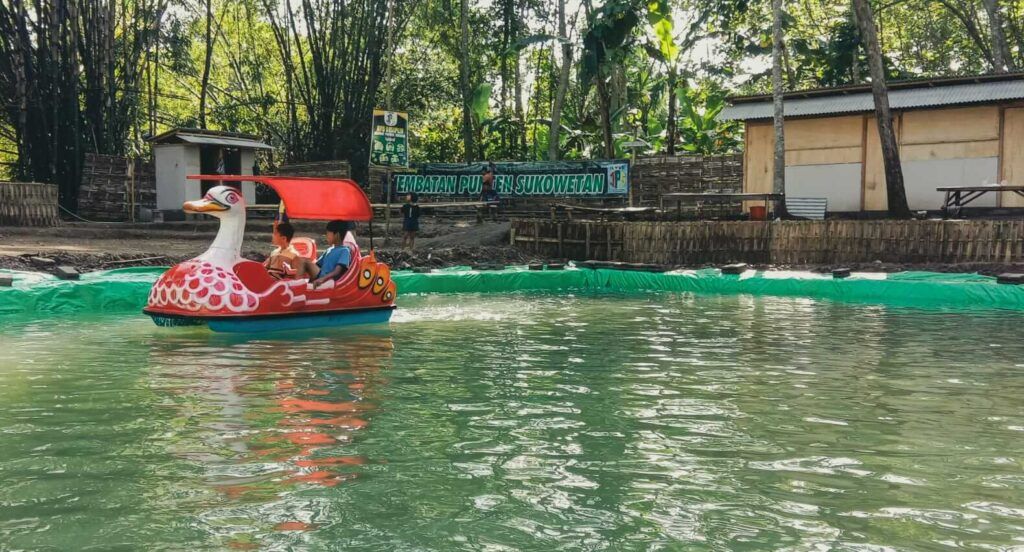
[{"left": 743, "top": 105, "right": 1024, "bottom": 212}]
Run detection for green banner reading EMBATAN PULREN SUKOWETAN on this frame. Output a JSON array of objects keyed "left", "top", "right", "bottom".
[{"left": 394, "top": 160, "right": 630, "bottom": 197}]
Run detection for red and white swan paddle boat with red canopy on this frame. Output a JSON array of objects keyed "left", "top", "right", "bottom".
[{"left": 142, "top": 175, "right": 396, "bottom": 332}]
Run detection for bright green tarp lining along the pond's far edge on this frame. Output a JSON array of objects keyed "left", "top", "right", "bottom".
[{"left": 0, "top": 267, "right": 1024, "bottom": 315}]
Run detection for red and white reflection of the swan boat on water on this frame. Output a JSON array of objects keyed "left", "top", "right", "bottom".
[{"left": 147, "top": 329, "right": 393, "bottom": 548}]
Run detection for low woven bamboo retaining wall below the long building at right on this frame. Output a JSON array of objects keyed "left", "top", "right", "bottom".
[{"left": 512, "top": 219, "right": 1024, "bottom": 265}]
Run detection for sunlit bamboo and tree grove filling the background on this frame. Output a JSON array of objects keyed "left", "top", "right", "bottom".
[{"left": 0, "top": 0, "right": 1024, "bottom": 208}]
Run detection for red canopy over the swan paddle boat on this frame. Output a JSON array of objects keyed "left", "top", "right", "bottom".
[{"left": 188, "top": 174, "right": 374, "bottom": 221}]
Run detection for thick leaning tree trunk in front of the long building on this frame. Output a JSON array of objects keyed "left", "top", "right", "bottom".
[{"left": 853, "top": 0, "right": 910, "bottom": 218}]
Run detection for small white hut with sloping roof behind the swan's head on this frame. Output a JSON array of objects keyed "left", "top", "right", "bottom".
[{"left": 148, "top": 128, "right": 272, "bottom": 212}]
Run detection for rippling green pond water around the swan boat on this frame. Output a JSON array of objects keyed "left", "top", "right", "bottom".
[{"left": 0, "top": 294, "right": 1024, "bottom": 551}]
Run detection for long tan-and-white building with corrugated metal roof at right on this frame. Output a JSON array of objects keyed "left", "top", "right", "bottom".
[{"left": 720, "top": 73, "right": 1024, "bottom": 212}]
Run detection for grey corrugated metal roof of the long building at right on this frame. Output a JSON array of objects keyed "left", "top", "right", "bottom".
[{"left": 718, "top": 79, "right": 1024, "bottom": 121}]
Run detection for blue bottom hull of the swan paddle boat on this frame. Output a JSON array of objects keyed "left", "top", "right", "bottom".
[{"left": 143, "top": 305, "right": 395, "bottom": 334}]
